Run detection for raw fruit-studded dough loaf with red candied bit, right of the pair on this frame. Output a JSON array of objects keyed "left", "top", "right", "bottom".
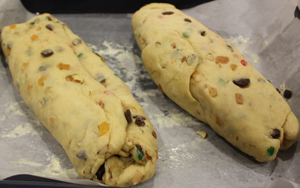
[{"left": 132, "top": 3, "right": 299, "bottom": 162}]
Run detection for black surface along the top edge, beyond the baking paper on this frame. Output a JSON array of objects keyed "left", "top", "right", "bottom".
[{"left": 21, "top": 0, "right": 211, "bottom": 14}]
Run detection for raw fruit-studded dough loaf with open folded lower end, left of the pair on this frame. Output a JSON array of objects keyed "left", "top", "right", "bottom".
[{"left": 1, "top": 14, "right": 158, "bottom": 186}]
